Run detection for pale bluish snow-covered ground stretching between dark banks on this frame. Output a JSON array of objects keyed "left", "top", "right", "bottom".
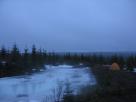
[{"left": 0, "top": 65, "right": 96, "bottom": 102}]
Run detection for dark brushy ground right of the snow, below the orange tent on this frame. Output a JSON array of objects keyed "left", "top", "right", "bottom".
[{"left": 67, "top": 66, "right": 136, "bottom": 102}]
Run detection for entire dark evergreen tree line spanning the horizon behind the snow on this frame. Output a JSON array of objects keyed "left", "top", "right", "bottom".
[{"left": 0, "top": 44, "right": 136, "bottom": 77}]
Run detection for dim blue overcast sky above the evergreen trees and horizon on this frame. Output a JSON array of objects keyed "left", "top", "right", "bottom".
[{"left": 0, "top": 0, "right": 136, "bottom": 52}]
